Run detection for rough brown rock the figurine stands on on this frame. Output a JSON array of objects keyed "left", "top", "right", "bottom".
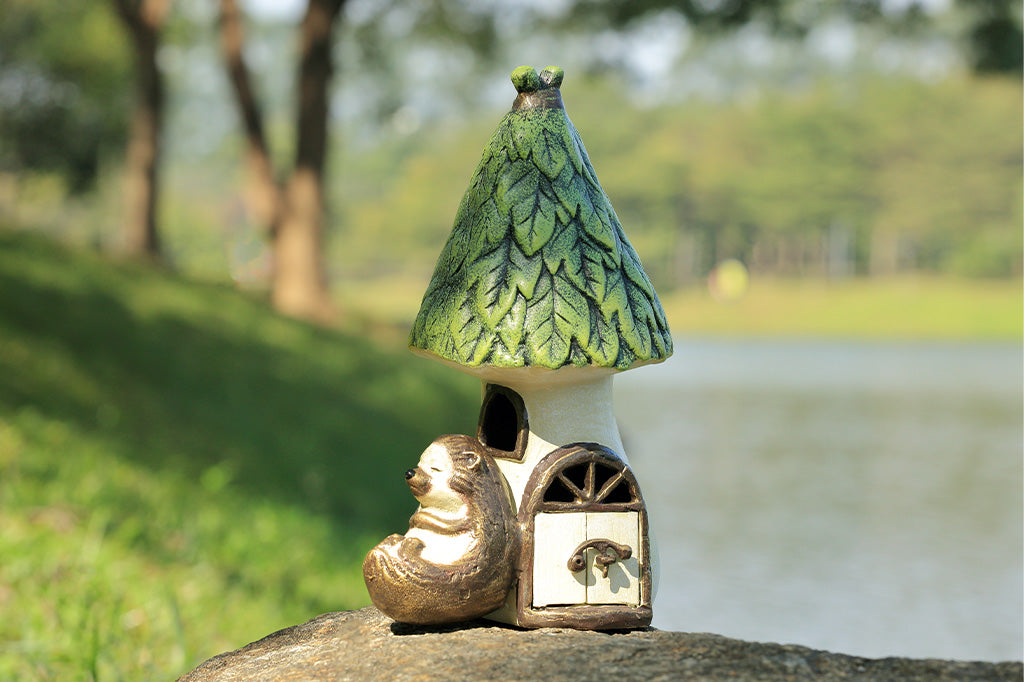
[{"left": 179, "top": 606, "right": 1022, "bottom": 682}]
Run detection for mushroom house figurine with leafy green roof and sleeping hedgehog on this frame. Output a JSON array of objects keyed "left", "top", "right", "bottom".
[{"left": 364, "top": 67, "right": 672, "bottom": 630}]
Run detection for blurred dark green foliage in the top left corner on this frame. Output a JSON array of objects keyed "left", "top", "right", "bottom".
[{"left": 0, "top": 0, "right": 129, "bottom": 193}]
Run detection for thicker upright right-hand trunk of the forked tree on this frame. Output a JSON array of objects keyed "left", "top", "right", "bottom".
[{"left": 271, "top": 0, "right": 344, "bottom": 319}]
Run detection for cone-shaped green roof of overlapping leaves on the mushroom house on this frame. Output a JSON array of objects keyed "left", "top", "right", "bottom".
[{"left": 410, "top": 67, "right": 672, "bottom": 371}]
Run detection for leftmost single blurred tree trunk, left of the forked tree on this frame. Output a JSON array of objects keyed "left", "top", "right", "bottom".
[{"left": 114, "top": 0, "right": 170, "bottom": 260}]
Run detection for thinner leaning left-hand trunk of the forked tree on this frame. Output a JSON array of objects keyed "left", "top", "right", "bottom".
[{"left": 219, "top": 0, "right": 285, "bottom": 240}]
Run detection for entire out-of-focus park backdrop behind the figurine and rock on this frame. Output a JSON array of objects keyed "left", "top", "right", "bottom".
[{"left": 0, "top": 0, "right": 1024, "bottom": 680}]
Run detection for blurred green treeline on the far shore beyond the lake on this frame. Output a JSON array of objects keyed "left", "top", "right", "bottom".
[{"left": 329, "top": 77, "right": 1024, "bottom": 288}]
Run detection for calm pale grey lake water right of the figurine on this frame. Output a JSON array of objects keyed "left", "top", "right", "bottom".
[{"left": 615, "top": 339, "right": 1024, "bottom": 660}]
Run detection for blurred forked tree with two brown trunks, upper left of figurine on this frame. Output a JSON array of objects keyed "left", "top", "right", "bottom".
[{"left": 219, "top": 0, "right": 496, "bottom": 318}]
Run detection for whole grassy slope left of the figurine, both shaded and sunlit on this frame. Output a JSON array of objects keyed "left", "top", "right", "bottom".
[{"left": 0, "top": 231, "right": 478, "bottom": 680}]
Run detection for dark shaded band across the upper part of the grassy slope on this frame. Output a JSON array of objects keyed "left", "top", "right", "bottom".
[{"left": 0, "top": 232, "right": 478, "bottom": 537}]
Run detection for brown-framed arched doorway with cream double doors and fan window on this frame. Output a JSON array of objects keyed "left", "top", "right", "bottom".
[{"left": 517, "top": 443, "right": 651, "bottom": 629}]
